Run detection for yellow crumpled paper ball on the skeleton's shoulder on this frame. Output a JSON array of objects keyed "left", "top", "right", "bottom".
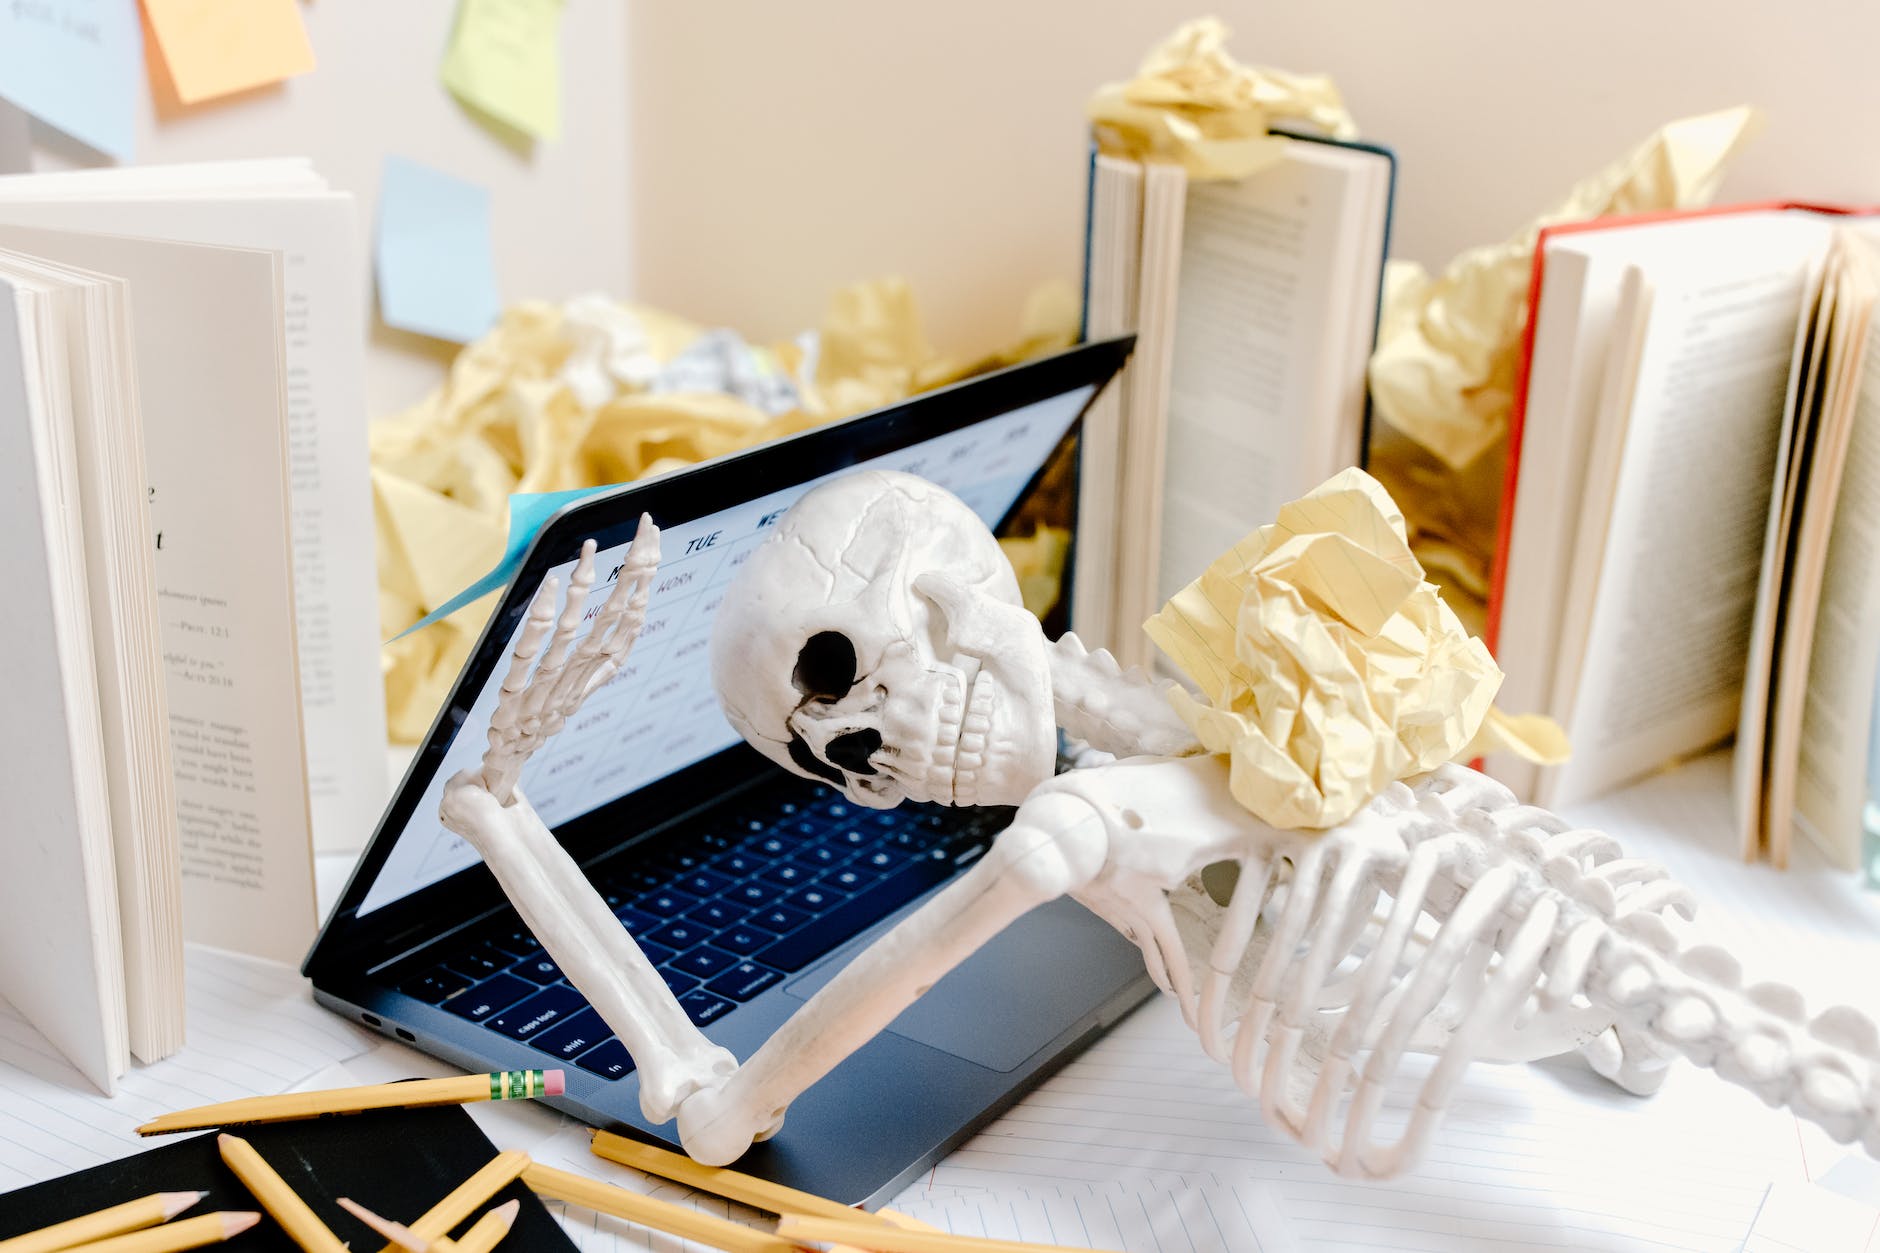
[{"left": 1145, "top": 468, "right": 1566, "bottom": 830}]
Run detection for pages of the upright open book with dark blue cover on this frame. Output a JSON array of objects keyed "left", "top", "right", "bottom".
[{"left": 1072, "top": 137, "right": 1395, "bottom": 666}]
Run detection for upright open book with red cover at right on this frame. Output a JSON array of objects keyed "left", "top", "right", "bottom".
[{"left": 1489, "top": 207, "right": 1880, "bottom": 860}]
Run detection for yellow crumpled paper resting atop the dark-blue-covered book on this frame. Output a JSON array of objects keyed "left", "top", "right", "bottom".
[{"left": 1087, "top": 17, "right": 1357, "bottom": 179}]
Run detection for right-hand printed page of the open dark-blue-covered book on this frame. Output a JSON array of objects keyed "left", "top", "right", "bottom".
[{"left": 1156, "top": 143, "right": 1372, "bottom": 604}]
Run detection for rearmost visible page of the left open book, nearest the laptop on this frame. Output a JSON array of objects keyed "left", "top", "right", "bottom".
[{"left": 0, "top": 192, "right": 389, "bottom": 849}]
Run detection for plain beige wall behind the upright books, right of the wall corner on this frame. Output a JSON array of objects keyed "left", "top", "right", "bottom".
[{"left": 630, "top": 0, "right": 1880, "bottom": 359}]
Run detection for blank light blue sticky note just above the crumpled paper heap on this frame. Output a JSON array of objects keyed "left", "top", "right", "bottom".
[{"left": 376, "top": 156, "right": 502, "bottom": 344}]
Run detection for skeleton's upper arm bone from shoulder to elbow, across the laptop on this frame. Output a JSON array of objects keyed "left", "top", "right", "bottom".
[{"left": 679, "top": 792, "right": 1107, "bottom": 1165}]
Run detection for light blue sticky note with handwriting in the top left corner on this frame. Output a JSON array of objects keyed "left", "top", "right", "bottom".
[{"left": 0, "top": 0, "right": 143, "bottom": 160}]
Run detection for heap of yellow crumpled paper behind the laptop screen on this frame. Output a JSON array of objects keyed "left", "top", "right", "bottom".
[{"left": 370, "top": 278, "right": 1077, "bottom": 743}]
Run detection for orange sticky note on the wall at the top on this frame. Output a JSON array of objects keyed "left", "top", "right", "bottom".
[{"left": 143, "top": 0, "right": 314, "bottom": 103}]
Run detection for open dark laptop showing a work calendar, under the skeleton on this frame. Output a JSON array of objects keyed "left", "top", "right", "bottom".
[{"left": 305, "top": 341, "right": 1151, "bottom": 1204}]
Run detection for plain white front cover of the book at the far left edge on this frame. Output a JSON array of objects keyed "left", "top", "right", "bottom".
[{"left": 0, "top": 273, "right": 130, "bottom": 1093}]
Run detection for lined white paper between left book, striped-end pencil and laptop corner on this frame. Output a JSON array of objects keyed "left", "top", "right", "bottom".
[{"left": 0, "top": 946, "right": 370, "bottom": 1191}]
